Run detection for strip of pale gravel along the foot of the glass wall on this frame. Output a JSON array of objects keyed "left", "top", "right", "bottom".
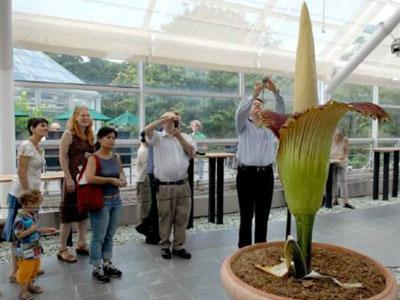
[{"left": 0, "top": 197, "right": 400, "bottom": 283}]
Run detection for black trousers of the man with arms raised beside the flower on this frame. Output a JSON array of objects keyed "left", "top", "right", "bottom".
[{"left": 236, "top": 166, "right": 274, "bottom": 248}]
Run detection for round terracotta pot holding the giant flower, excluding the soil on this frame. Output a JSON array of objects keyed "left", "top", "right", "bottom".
[{"left": 221, "top": 241, "right": 398, "bottom": 300}]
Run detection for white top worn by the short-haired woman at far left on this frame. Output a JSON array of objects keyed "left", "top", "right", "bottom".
[{"left": 9, "top": 140, "right": 45, "bottom": 198}]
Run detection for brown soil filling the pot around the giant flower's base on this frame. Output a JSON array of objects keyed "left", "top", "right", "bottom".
[{"left": 231, "top": 247, "right": 385, "bottom": 300}]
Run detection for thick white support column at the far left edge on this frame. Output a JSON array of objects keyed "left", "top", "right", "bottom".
[{"left": 0, "top": 0, "right": 15, "bottom": 217}]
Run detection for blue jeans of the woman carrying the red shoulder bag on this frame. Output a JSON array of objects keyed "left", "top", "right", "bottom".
[{"left": 89, "top": 195, "right": 122, "bottom": 267}]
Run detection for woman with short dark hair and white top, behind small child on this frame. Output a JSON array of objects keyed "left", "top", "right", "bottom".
[{"left": 2, "top": 118, "right": 49, "bottom": 283}]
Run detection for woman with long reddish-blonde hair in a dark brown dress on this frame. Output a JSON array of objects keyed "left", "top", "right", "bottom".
[{"left": 57, "top": 106, "right": 94, "bottom": 263}]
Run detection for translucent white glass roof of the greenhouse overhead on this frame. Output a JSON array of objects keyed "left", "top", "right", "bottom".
[{"left": 13, "top": 0, "right": 400, "bottom": 85}]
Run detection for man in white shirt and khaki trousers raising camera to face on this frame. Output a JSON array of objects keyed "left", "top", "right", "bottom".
[{"left": 144, "top": 112, "right": 196, "bottom": 259}]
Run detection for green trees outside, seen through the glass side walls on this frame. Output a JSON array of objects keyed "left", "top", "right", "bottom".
[{"left": 21, "top": 52, "right": 400, "bottom": 168}]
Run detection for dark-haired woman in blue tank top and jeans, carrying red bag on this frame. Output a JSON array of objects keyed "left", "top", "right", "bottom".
[{"left": 84, "top": 127, "right": 126, "bottom": 282}]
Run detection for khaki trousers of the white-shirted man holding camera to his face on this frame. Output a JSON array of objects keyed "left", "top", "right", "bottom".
[{"left": 157, "top": 181, "right": 191, "bottom": 250}]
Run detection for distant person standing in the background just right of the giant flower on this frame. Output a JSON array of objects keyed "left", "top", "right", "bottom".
[{"left": 331, "top": 129, "right": 355, "bottom": 209}]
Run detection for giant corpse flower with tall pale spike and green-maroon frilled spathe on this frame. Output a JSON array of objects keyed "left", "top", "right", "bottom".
[{"left": 262, "top": 3, "right": 389, "bottom": 278}]
